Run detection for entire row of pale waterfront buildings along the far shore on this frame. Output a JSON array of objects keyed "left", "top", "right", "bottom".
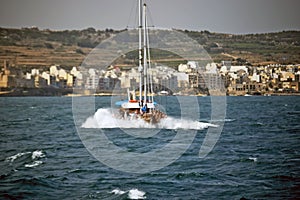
[{"left": 0, "top": 61, "right": 300, "bottom": 95}]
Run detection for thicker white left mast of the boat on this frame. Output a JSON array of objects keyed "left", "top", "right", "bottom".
[{"left": 138, "top": 0, "right": 143, "bottom": 101}]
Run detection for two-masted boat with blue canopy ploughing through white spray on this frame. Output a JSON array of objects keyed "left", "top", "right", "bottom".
[{"left": 116, "top": 0, "right": 167, "bottom": 124}]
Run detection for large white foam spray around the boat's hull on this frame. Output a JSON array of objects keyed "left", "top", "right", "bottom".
[{"left": 82, "top": 108, "right": 216, "bottom": 130}]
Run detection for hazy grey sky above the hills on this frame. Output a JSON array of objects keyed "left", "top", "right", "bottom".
[{"left": 0, "top": 0, "right": 300, "bottom": 33}]
